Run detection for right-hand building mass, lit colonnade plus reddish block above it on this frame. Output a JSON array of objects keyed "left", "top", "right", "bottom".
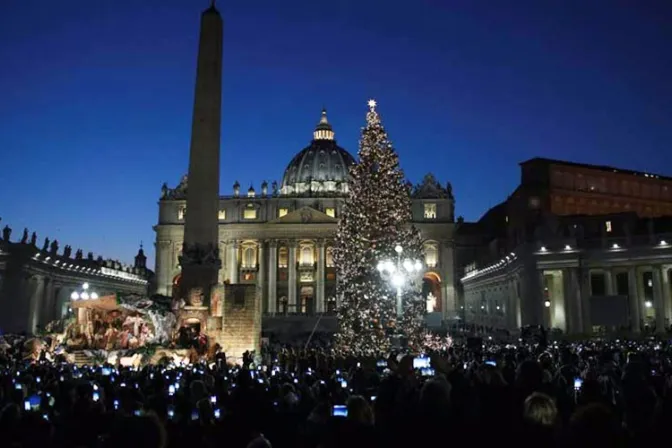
[{"left": 456, "top": 159, "right": 672, "bottom": 334}]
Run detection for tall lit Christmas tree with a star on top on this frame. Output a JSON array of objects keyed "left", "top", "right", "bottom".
[{"left": 334, "top": 100, "right": 425, "bottom": 355}]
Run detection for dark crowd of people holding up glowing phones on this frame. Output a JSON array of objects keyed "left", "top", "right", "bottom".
[{"left": 0, "top": 337, "right": 672, "bottom": 448}]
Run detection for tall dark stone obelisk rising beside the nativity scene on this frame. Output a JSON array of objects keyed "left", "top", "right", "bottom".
[{"left": 180, "top": 0, "right": 222, "bottom": 306}]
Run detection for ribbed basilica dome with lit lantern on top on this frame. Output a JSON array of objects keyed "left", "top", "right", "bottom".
[{"left": 280, "top": 110, "right": 355, "bottom": 195}]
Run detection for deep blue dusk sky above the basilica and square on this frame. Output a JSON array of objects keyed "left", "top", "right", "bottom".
[{"left": 0, "top": 0, "right": 672, "bottom": 265}]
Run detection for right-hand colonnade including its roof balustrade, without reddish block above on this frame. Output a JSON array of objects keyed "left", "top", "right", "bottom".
[{"left": 461, "top": 229, "right": 672, "bottom": 334}]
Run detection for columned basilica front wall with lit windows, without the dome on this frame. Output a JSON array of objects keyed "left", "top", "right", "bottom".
[{"left": 155, "top": 196, "right": 455, "bottom": 317}]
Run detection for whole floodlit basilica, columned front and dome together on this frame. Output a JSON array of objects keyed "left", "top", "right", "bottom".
[{"left": 154, "top": 111, "right": 455, "bottom": 320}]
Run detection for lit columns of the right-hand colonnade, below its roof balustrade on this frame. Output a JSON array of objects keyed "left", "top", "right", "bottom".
[{"left": 463, "top": 264, "right": 672, "bottom": 334}]
